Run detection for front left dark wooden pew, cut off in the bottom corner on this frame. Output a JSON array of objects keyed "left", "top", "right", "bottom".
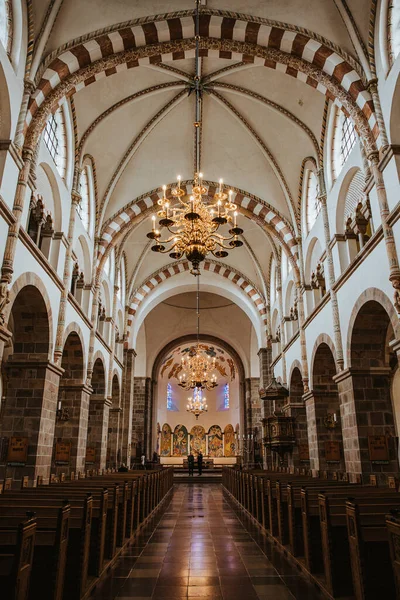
[{"left": 0, "top": 517, "right": 36, "bottom": 600}]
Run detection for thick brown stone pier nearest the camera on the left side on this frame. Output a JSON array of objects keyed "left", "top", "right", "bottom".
[{"left": 0, "top": 354, "right": 63, "bottom": 489}]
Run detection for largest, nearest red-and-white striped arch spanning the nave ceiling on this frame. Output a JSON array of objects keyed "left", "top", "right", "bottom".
[{"left": 25, "top": 8, "right": 379, "bottom": 147}]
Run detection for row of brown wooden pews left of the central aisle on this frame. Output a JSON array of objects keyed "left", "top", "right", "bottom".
[{"left": 0, "top": 468, "right": 173, "bottom": 600}]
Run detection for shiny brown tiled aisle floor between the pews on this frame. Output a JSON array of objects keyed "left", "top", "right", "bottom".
[{"left": 94, "top": 484, "right": 320, "bottom": 600}]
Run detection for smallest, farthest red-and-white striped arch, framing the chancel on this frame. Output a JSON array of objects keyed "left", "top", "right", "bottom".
[{"left": 127, "top": 259, "right": 267, "bottom": 333}]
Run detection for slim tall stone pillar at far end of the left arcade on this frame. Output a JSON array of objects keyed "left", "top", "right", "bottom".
[{"left": 121, "top": 348, "right": 136, "bottom": 465}]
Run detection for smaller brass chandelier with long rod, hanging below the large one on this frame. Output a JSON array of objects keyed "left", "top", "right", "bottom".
[{"left": 178, "top": 277, "right": 218, "bottom": 390}]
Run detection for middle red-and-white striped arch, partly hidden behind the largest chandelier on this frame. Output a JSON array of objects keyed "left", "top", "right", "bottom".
[{"left": 97, "top": 181, "right": 299, "bottom": 267}]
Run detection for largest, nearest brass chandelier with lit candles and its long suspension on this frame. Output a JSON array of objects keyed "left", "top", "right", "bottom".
[{"left": 147, "top": 0, "right": 243, "bottom": 276}]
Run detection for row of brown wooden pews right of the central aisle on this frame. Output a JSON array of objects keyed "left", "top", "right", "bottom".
[{"left": 222, "top": 468, "right": 400, "bottom": 600}]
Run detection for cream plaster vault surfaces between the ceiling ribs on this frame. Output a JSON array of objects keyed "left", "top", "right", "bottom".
[{"left": 33, "top": 0, "right": 369, "bottom": 344}]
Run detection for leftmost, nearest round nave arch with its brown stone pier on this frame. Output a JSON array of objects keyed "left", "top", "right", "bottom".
[{"left": 0, "top": 273, "right": 54, "bottom": 489}]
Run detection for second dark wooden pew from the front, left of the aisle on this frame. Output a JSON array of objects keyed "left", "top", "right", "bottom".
[{"left": 0, "top": 501, "right": 70, "bottom": 600}]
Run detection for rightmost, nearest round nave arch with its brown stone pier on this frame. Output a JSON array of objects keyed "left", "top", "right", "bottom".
[{"left": 343, "top": 288, "right": 400, "bottom": 479}]
